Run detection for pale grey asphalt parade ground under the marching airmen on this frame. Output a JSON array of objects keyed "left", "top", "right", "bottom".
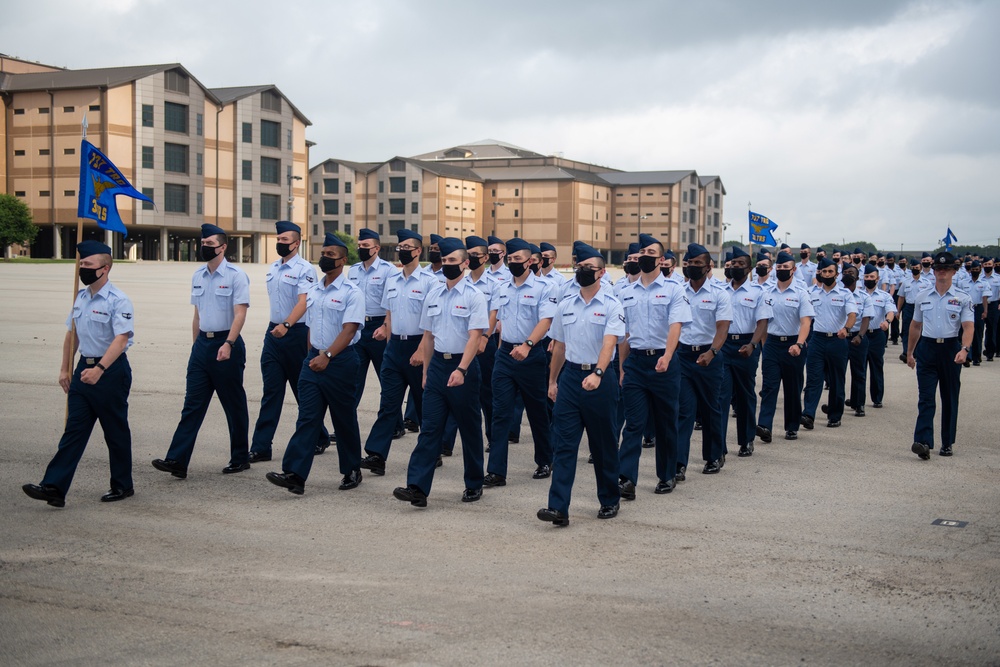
[{"left": 0, "top": 263, "right": 1000, "bottom": 666}]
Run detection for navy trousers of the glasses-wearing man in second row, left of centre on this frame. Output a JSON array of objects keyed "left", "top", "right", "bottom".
[{"left": 365, "top": 334, "right": 424, "bottom": 459}]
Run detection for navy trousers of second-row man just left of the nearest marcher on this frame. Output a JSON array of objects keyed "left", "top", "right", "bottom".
[{"left": 486, "top": 342, "right": 552, "bottom": 477}]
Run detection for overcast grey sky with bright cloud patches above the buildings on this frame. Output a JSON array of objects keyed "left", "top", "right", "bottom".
[{"left": 0, "top": 0, "right": 1000, "bottom": 249}]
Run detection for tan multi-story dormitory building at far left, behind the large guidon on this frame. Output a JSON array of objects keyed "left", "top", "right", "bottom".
[{"left": 0, "top": 55, "right": 311, "bottom": 262}]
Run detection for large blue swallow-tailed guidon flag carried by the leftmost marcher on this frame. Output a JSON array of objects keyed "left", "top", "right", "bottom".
[{"left": 76, "top": 139, "right": 153, "bottom": 236}]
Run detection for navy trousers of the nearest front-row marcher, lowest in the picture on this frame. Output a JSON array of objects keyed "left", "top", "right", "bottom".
[{"left": 549, "top": 362, "right": 621, "bottom": 514}]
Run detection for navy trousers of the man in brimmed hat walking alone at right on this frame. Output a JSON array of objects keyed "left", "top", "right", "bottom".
[{"left": 913, "top": 336, "right": 962, "bottom": 449}]
